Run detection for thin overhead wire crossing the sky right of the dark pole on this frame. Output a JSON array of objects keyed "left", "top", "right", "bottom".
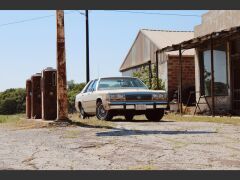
[{"left": 104, "top": 10, "right": 201, "bottom": 17}]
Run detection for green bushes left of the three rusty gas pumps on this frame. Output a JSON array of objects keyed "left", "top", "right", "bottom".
[{"left": 0, "top": 88, "right": 26, "bottom": 114}]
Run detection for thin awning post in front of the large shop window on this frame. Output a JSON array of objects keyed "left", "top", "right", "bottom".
[{"left": 211, "top": 35, "right": 215, "bottom": 116}]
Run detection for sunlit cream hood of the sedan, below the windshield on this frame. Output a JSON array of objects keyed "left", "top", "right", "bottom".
[{"left": 98, "top": 89, "right": 166, "bottom": 93}]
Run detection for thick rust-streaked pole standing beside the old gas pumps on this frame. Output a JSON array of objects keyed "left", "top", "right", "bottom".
[{"left": 56, "top": 10, "right": 68, "bottom": 120}]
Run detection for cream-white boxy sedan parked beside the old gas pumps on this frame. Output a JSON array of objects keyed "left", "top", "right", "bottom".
[{"left": 75, "top": 77, "right": 168, "bottom": 121}]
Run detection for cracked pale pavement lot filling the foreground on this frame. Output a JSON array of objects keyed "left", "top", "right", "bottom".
[{"left": 0, "top": 114, "right": 240, "bottom": 170}]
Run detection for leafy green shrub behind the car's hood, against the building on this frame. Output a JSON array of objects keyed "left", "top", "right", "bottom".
[{"left": 133, "top": 65, "right": 165, "bottom": 90}]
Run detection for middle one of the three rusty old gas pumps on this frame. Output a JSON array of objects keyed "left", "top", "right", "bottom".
[{"left": 31, "top": 73, "right": 42, "bottom": 119}]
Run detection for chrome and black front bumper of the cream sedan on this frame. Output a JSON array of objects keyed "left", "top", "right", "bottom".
[{"left": 105, "top": 101, "right": 168, "bottom": 110}]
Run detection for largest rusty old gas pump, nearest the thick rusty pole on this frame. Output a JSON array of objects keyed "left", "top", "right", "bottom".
[{"left": 41, "top": 68, "right": 57, "bottom": 120}]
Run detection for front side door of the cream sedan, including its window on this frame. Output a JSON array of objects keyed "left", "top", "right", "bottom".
[{"left": 85, "top": 79, "right": 98, "bottom": 114}]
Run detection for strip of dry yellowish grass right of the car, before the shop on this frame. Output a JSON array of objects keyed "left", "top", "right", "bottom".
[{"left": 163, "top": 113, "right": 240, "bottom": 125}]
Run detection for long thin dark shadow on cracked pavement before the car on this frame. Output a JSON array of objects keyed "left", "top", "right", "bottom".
[{"left": 96, "top": 129, "right": 216, "bottom": 136}]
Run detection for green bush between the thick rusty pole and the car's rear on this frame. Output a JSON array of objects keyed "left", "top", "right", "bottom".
[{"left": 68, "top": 80, "right": 86, "bottom": 113}]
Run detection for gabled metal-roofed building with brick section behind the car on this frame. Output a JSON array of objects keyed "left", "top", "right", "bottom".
[{"left": 120, "top": 29, "right": 195, "bottom": 100}]
